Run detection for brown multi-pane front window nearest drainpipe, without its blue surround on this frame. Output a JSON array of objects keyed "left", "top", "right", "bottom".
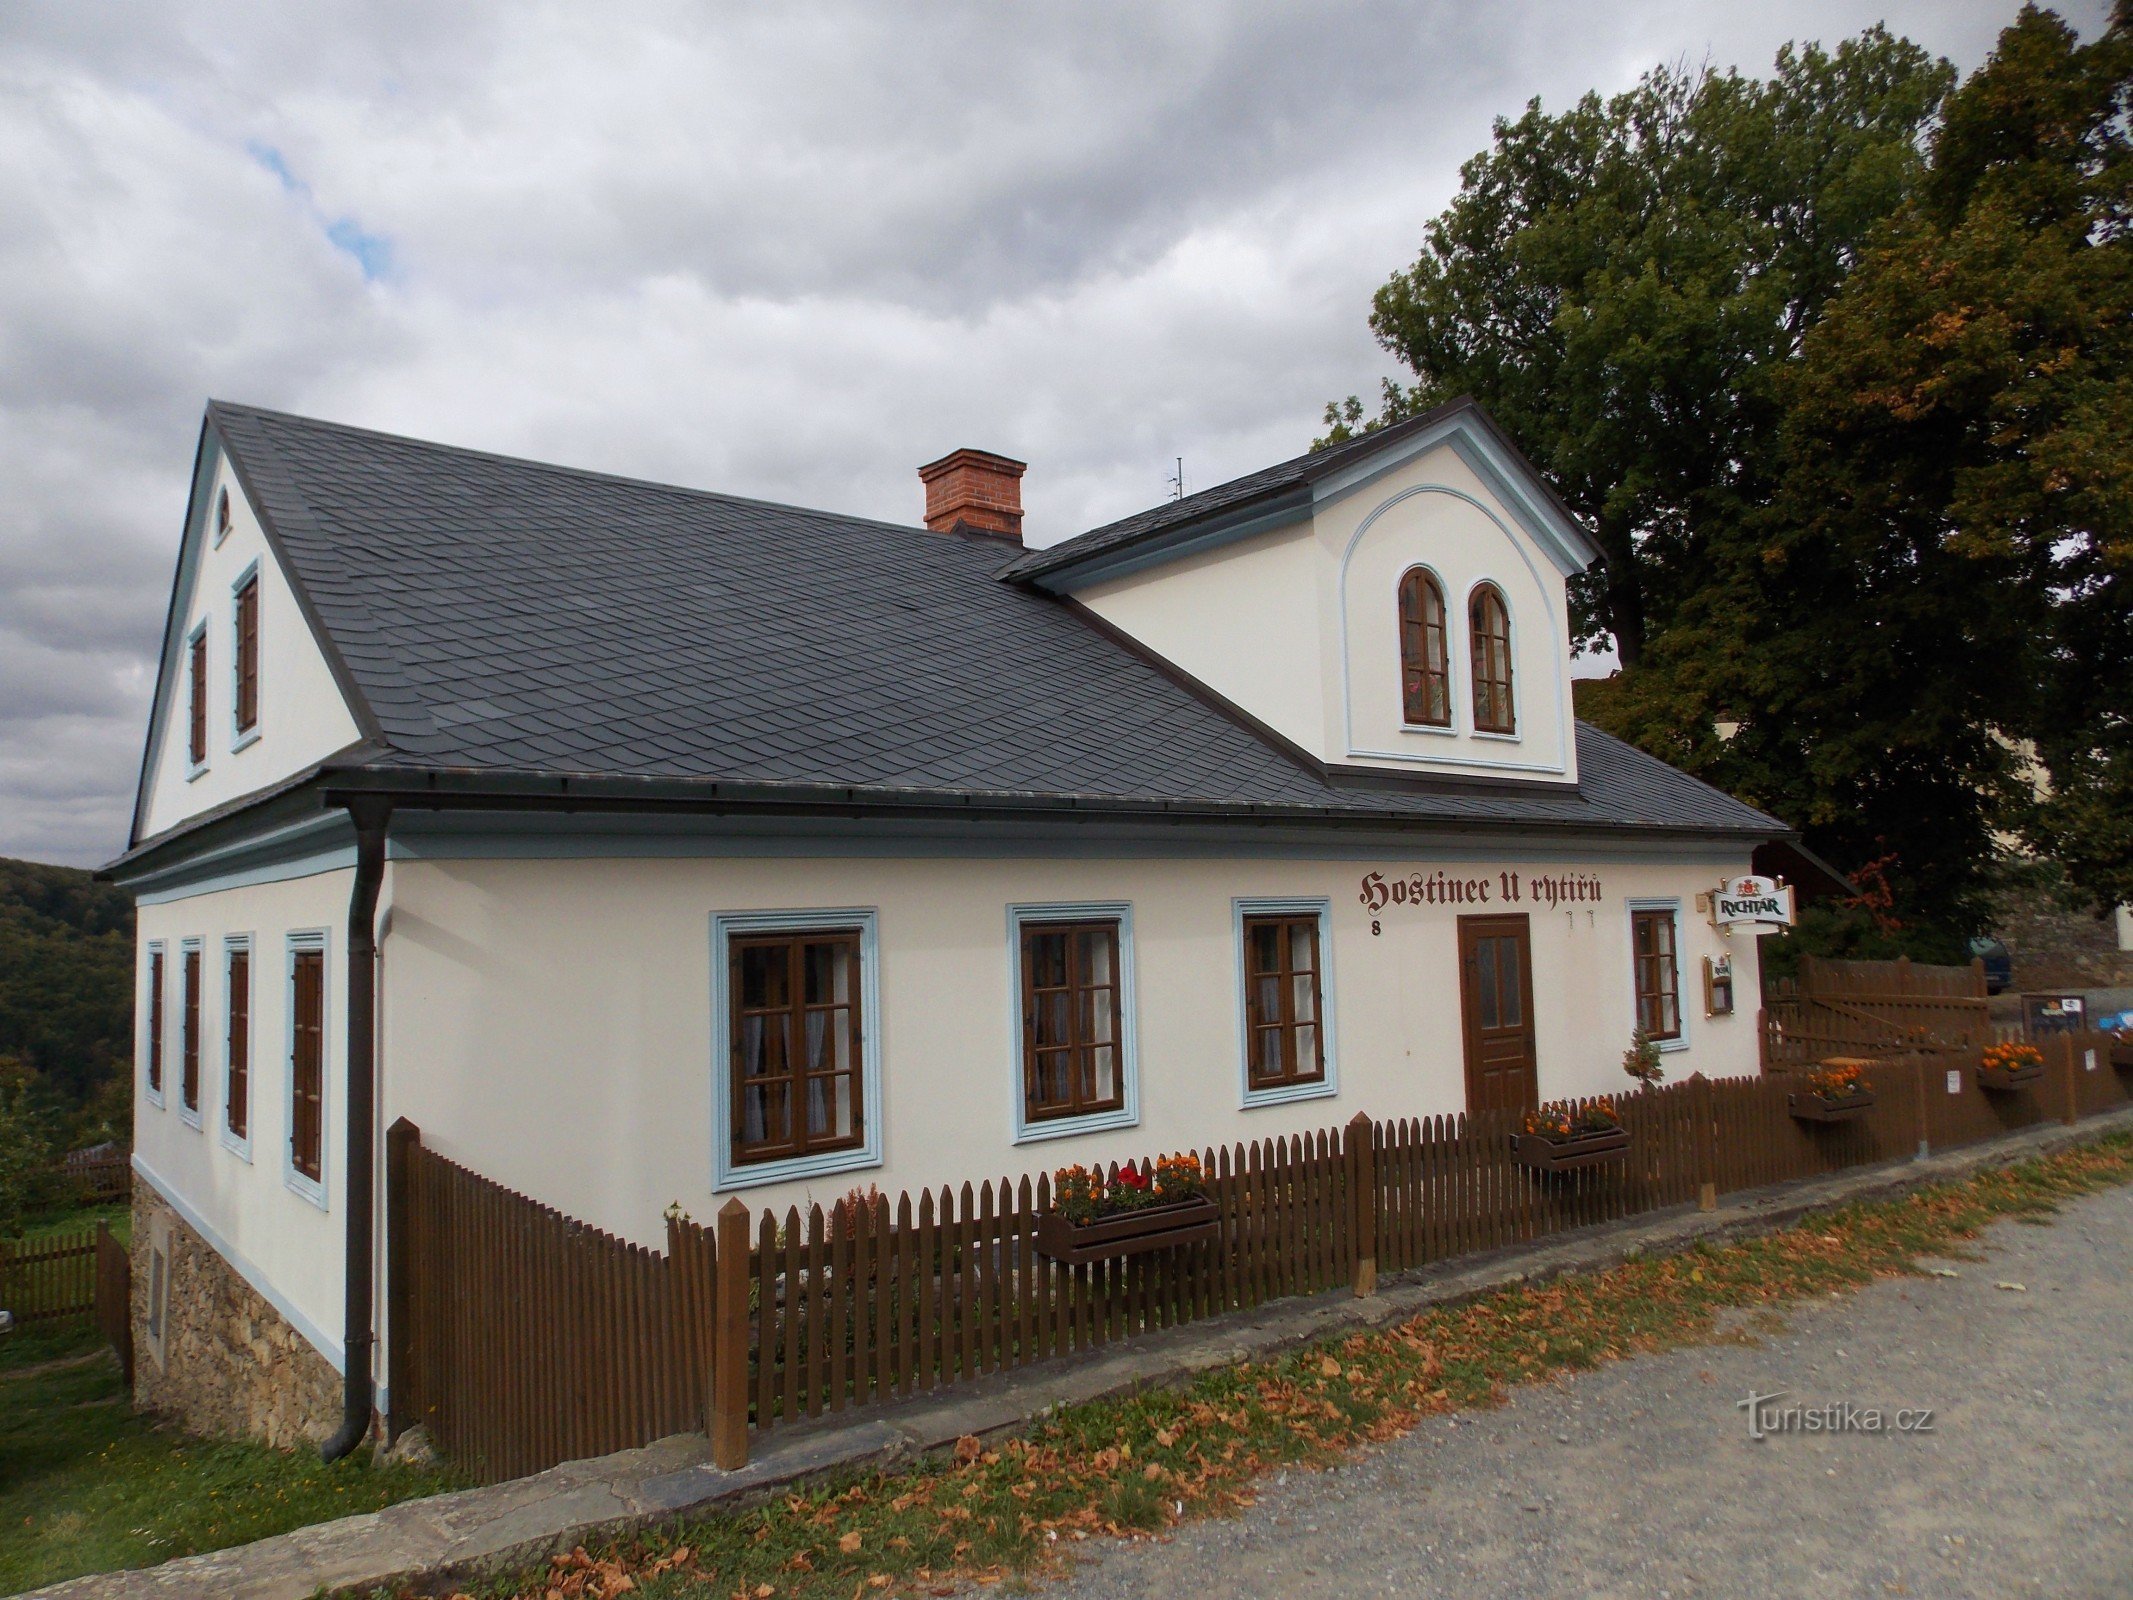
[{"left": 727, "top": 928, "right": 866, "bottom": 1165}]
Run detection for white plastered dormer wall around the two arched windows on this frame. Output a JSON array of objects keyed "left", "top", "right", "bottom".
[{"left": 1075, "top": 444, "right": 1576, "bottom": 783}]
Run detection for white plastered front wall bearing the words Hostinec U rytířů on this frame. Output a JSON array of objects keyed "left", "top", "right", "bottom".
[{"left": 382, "top": 855, "right": 1758, "bottom": 1244}]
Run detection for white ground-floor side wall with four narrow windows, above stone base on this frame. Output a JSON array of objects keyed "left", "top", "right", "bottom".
[{"left": 134, "top": 870, "right": 354, "bottom": 1365}]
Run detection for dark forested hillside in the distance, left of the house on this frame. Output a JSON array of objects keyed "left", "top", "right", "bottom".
[{"left": 0, "top": 855, "right": 132, "bottom": 1118}]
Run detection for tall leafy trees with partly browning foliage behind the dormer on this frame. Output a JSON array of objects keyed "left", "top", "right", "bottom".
[{"left": 1344, "top": 6, "right": 2133, "bottom": 954}]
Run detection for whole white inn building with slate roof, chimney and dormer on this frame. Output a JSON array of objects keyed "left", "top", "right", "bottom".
[{"left": 109, "top": 403, "right": 1785, "bottom": 1449}]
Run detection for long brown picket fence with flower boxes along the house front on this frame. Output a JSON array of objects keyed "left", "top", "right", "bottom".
[{"left": 388, "top": 1035, "right": 2133, "bottom": 1478}]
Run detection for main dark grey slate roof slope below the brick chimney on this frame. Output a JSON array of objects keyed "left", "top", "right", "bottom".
[{"left": 209, "top": 403, "right": 1785, "bottom": 836}]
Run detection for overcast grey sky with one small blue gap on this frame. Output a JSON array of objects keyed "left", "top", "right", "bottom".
[{"left": 0, "top": 0, "right": 2103, "bottom": 864}]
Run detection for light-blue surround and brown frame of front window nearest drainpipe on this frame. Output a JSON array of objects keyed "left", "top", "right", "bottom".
[{"left": 710, "top": 907, "right": 883, "bottom": 1193}]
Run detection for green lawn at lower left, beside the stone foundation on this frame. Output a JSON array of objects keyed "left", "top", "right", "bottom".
[{"left": 0, "top": 1318, "right": 459, "bottom": 1594}]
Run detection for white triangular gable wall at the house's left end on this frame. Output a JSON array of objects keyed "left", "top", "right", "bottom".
[{"left": 141, "top": 452, "right": 358, "bottom": 838}]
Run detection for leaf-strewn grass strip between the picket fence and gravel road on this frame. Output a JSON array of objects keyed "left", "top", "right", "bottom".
[{"left": 375, "top": 1135, "right": 2133, "bottom": 1600}]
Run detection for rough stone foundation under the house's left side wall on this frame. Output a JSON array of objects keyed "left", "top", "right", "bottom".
[{"left": 132, "top": 1182, "right": 341, "bottom": 1449}]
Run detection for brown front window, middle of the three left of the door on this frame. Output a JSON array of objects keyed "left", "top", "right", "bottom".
[{"left": 1022, "top": 917, "right": 1126, "bottom": 1122}]
